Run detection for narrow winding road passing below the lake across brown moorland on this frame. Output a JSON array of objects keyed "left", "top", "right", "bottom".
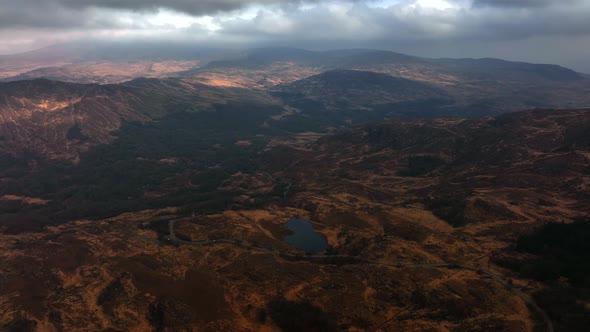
[{"left": 168, "top": 220, "right": 554, "bottom": 332}]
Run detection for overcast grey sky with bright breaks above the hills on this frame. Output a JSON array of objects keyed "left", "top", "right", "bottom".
[{"left": 0, "top": 0, "right": 590, "bottom": 73}]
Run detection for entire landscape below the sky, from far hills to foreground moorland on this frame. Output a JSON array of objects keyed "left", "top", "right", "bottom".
[{"left": 0, "top": 48, "right": 590, "bottom": 331}]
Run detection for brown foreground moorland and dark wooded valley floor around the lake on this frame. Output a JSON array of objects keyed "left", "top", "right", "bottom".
[{"left": 0, "top": 108, "right": 590, "bottom": 331}]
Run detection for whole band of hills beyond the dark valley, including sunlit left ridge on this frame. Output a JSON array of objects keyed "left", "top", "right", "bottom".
[{"left": 0, "top": 45, "right": 590, "bottom": 159}]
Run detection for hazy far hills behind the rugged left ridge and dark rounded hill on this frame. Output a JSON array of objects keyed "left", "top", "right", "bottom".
[{"left": 0, "top": 43, "right": 590, "bottom": 117}]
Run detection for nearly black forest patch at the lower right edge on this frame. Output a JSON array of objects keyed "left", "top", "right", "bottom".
[{"left": 508, "top": 219, "right": 590, "bottom": 331}]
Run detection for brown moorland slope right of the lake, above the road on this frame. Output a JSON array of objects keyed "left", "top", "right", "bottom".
[{"left": 268, "top": 109, "right": 590, "bottom": 331}]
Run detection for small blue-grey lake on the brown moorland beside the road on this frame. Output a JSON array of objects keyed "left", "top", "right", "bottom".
[{"left": 285, "top": 218, "right": 328, "bottom": 253}]
